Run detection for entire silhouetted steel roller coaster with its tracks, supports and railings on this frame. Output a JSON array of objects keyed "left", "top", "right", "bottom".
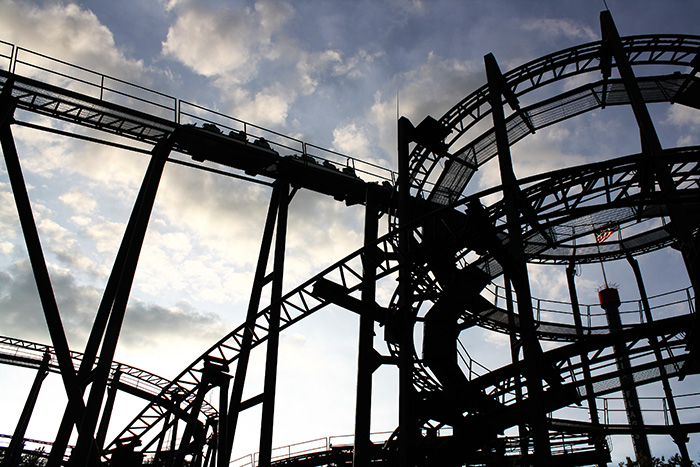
[{"left": 0, "top": 11, "right": 700, "bottom": 467}]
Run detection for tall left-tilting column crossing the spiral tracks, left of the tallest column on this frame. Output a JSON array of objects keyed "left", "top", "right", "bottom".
[{"left": 484, "top": 54, "right": 551, "bottom": 466}]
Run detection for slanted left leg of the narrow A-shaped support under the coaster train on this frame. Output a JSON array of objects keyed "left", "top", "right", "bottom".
[{"left": 226, "top": 184, "right": 282, "bottom": 453}]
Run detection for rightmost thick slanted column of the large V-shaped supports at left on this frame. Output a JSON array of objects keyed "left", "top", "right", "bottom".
[{"left": 71, "top": 135, "right": 174, "bottom": 467}]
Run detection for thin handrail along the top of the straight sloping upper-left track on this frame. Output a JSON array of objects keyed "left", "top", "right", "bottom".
[{"left": 0, "top": 41, "right": 397, "bottom": 184}]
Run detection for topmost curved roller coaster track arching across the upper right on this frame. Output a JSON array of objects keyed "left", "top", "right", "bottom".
[{"left": 410, "top": 36, "right": 700, "bottom": 204}]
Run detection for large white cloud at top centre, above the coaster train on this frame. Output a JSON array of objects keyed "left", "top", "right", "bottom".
[{"left": 162, "top": 1, "right": 382, "bottom": 132}]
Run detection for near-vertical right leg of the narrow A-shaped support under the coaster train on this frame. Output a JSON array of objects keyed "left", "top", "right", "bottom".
[{"left": 259, "top": 180, "right": 290, "bottom": 467}]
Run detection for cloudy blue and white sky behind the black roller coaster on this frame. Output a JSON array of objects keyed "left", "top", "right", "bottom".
[{"left": 0, "top": 0, "right": 700, "bottom": 461}]
